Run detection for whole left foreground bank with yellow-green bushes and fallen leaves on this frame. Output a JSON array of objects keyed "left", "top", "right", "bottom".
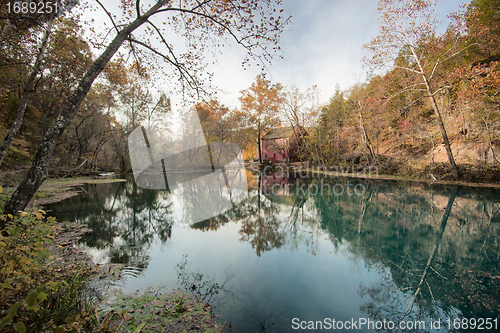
[{"left": 0, "top": 179, "right": 224, "bottom": 333}]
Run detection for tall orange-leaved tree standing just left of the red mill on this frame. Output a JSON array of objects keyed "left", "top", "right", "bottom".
[{"left": 240, "top": 74, "right": 283, "bottom": 163}]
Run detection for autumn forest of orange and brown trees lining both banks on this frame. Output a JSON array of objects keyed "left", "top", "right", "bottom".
[{"left": 0, "top": 0, "right": 500, "bottom": 201}]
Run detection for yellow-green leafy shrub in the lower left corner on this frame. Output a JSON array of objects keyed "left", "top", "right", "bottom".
[{"left": 0, "top": 187, "right": 113, "bottom": 332}]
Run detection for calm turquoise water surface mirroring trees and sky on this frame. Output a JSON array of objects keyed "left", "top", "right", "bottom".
[{"left": 47, "top": 174, "right": 500, "bottom": 332}]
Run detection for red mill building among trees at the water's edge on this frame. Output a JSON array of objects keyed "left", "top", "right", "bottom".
[{"left": 261, "top": 127, "right": 302, "bottom": 163}]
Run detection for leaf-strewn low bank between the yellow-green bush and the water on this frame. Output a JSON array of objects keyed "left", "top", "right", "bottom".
[{"left": 50, "top": 222, "right": 223, "bottom": 333}]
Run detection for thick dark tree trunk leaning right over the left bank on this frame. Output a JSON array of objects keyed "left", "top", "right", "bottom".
[{"left": 0, "top": 1, "right": 164, "bottom": 220}]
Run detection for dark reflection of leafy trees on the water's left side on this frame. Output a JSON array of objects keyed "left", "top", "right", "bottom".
[{"left": 48, "top": 182, "right": 173, "bottom": 277}]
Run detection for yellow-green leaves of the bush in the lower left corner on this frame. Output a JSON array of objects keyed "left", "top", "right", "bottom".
[{"left": 0, "top": 205, "right": 86, "bottom": 332}]
